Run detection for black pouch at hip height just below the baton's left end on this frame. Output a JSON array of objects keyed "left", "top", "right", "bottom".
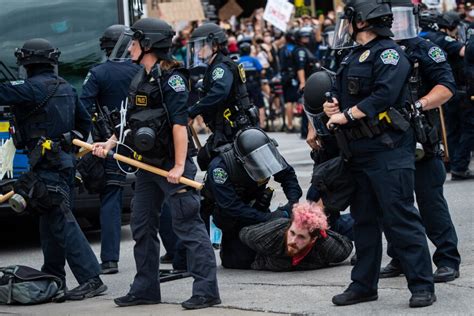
[{"left": 76, "top": 153, "right": 105, "bottom": 194}]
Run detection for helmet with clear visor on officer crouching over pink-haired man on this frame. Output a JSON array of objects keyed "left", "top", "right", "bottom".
[{"left": 234, "top": 127, "right": 287, "bottom": 182}]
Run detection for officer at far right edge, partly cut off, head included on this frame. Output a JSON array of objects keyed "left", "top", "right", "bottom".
[{"left": 420, "top": 12, "right": 474, "bottom": 180}]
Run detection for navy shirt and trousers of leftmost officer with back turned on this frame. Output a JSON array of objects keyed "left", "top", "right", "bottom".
[{"left": 0, "top": 68, "right": 100, "bottom": 284}]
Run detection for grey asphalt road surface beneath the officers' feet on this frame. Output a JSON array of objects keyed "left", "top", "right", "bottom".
[{"left": 0, "top": 133, "right": 474, "bottom": 315}]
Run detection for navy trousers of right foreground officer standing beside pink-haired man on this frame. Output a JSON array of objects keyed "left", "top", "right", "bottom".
[{"left": 349, "top": 139, "right": 434, "bottom": 293}]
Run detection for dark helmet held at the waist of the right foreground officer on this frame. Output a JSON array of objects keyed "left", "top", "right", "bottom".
[{"left": 303, "top": 70, "right": 334, "bottom": 136}]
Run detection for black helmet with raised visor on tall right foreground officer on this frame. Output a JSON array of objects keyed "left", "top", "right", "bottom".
[{"left": 335, "top": 0, "right": 393, "bottom": 49}]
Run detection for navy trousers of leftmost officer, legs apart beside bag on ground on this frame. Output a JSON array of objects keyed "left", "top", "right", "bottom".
[{"left": 38, "top": 169, "right": 100, "bottom": 284}]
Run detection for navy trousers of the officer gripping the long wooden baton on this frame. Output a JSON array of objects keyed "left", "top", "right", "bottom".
[{"left": 130, "top": 158, "right": 219, "bottom": 300}]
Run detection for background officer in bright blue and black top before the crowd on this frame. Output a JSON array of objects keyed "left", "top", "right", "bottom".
[{"left": 239, "top": 41, "right": 264, "bottom": 109}]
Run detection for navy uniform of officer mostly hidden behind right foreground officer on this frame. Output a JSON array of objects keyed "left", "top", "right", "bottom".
[{"left": 388, "top": 37, "right": 461, "bottom": 271}]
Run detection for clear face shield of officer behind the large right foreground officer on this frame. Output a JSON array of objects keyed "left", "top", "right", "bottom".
[{"left": 391, "top": 7, "right": 418, "bottom": 41}]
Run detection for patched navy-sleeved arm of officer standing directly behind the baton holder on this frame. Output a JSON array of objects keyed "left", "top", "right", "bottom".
[{"left": 188, "top": 64, "right": 234, "bottom": 119}]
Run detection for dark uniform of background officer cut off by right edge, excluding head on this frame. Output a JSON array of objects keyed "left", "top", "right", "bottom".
[{"left": 420, "top": 31, "right": 474, "bottom": 173}]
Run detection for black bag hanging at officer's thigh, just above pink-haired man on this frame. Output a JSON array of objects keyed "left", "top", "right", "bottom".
[{"left": 311, "top": 157, "right": 355, "bottom": 214}]
